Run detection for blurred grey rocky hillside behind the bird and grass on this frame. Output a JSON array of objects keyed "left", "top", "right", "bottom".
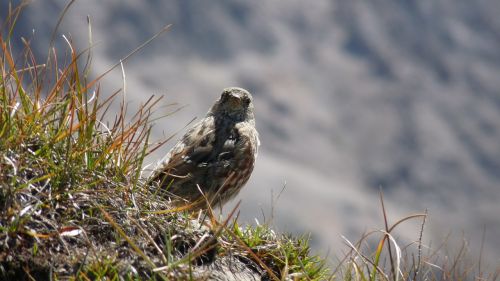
[{"left": 0, "top": 0, "right": 500, "bottom": 262}]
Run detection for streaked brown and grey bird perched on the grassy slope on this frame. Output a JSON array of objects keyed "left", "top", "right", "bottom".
[{"left": 149, "top": 87, "right": 260, "bottom": 210}]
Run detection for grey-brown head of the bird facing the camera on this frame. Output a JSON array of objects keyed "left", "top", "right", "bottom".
[{"left": 209, "top": 87, "right": 254, "bottom": 122}]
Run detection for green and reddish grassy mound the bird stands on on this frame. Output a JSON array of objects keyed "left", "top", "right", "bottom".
[{"left": 0, "top": 2, "right": 326, "bottom": 280}]
